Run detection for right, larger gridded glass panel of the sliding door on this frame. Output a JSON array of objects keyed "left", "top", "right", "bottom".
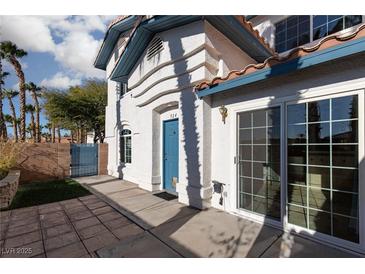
[{"left": 287, "top": 95, "right": 359, "bottom": 243}]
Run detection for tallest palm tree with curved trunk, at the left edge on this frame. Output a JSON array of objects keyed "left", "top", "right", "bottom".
[{"left": 0, "top": 41, "right": 27, "bottom": 142}]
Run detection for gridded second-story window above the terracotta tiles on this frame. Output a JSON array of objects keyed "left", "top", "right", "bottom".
[{"left": 275, "top": 15, "right": 362, "bottom": 53}]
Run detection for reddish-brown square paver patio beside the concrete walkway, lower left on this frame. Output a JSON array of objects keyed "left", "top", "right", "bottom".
[{"left": 0, "top": 195, "right": 144, "bottom": 258}]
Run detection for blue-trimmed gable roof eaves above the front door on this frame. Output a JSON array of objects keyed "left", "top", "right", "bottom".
[{"left": 95, "top": 15, "right": 273, "bottom": 81}]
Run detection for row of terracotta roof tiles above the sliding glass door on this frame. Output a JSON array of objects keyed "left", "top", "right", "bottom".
[{"left": 195, "top": 24, "right": 365, "bottom": 91}]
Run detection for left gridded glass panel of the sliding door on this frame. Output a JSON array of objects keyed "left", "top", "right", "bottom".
[{"left": 238, "top": 107, "right": 281, "bottom": 220}]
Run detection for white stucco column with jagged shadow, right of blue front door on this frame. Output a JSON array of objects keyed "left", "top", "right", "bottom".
[{"left": 177, "top": 90, "right": 212, "bottom": 209}]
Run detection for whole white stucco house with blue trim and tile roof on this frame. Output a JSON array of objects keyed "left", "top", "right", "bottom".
[{"left": 95, "top": 15, "right": 365, "bottom": 253}]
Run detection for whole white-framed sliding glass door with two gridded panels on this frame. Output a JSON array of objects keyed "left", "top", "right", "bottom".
[{"left": 237, "top": 93, "right": 365, "bottom": 248}]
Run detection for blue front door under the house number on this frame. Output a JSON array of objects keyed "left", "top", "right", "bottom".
[{"left": 163, "top": 119, "right": 179, "bottom": 193}]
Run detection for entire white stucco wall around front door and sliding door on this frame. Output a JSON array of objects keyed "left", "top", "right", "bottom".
[{"left": 101, "top": 18, "right": 365, "bottom": 249}]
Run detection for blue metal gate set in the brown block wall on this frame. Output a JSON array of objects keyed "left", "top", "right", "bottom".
[{"left": 70, "top": 144, "right": 99, "bottom": 177}]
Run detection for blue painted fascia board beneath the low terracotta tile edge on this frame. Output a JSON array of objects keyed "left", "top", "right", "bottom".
[{"left": 197, "top": 37, "right": 365, "bottom": 98}]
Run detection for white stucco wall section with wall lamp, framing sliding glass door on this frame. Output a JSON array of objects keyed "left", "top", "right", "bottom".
[{"left": 211, "top": 54, "right": 365, "bottom": 213}]
